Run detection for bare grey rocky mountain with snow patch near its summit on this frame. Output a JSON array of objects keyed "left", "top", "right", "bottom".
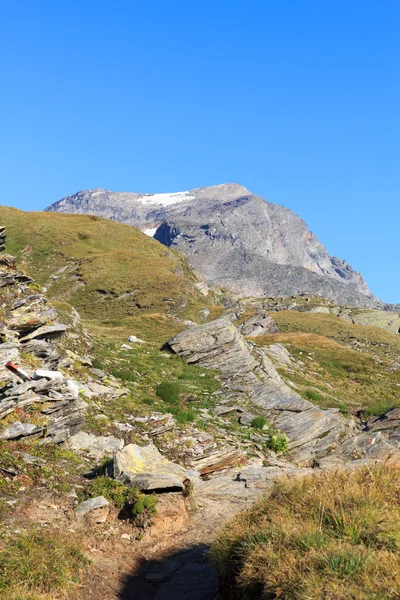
[{"left": 46, "top": 184, "right": 380, "bottom": 306}]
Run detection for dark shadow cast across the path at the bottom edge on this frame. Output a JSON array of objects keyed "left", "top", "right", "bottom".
[{"left": 119, "top": 544, "right": 218, "bottom": 600}]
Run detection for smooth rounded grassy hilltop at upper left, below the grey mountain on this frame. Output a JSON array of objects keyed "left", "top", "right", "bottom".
[{"left": 0, "top": 207, "right": 218, "bottom": 338}]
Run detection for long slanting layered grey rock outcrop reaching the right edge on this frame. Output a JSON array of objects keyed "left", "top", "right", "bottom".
[{"left": 168, "top": 318, "right": 400, "bottom": 466}]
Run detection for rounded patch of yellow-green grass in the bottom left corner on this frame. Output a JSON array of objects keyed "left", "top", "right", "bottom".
[{"left": 0, "top": 531, "right": 87, "bottom": 598}]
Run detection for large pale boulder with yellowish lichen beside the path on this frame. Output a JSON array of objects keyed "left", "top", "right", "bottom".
[{"left": 114, "top": 444, "right": 185, "bottom": 491}]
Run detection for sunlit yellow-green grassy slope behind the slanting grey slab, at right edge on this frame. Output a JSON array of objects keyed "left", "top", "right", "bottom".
[{"left": 252, "top": 311, "right": 400, "bottom": 414}]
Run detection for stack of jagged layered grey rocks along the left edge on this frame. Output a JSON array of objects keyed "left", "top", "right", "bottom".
[{"left": 0, "top": 228, "right": 85, "bottom": 444}]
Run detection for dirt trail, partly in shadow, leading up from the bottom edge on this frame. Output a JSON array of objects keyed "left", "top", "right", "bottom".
[{"left": 95, "top": 478, "right": 258, "bottom": 600}]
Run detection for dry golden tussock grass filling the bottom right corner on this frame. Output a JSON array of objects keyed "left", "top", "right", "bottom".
[{"left": 212, "top": 465, "right": 400, "bottom": 600}]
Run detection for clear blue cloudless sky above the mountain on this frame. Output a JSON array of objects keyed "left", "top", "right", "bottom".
[{"left": 0, "top": 0, "right": 400, "bottom": 302}]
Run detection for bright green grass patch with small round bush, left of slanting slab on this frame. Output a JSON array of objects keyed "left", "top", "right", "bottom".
[{"left": 80, "top": 339, "right": 220, "bottom": 436}]
